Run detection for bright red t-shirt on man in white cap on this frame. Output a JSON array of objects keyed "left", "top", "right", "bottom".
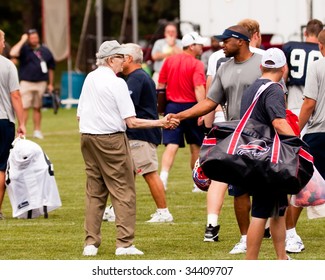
[{"left": 158, "top": 53, "right": 206, "bottom": 103}]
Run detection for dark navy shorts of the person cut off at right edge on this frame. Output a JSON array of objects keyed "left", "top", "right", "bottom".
[{"left": 303, "top": 132, "right": 325, "bottom": 179}]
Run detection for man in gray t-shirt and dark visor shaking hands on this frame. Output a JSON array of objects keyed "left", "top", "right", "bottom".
[{"left": 171, "top": 25, "right": 262, "bottom": 254}]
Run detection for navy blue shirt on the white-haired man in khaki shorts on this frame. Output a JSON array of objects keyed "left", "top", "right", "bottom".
[{"left": 126, "top": 69, "right": 161, "bottom": 145}]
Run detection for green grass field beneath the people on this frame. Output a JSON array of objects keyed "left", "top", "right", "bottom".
[{"left": 0, "top": 109, "right": 325, "bottom": 260}]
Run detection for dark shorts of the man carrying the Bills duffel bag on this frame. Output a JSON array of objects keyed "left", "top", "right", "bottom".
[{"left": 252, "top": 193, "right": 288, "bottom": 219}]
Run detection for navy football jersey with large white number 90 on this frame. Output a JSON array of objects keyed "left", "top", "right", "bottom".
[{"left": 282, "top": 42, "right": 322, "bottom": 86}]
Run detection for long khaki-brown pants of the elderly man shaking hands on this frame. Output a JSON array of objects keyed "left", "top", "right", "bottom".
[{"left": 81, "top": 133, "right": 136, "bottom": 247}]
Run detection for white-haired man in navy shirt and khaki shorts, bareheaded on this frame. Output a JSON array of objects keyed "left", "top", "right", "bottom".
[{"left": 123, "top": 43, "right": 173, "bottom": 223}]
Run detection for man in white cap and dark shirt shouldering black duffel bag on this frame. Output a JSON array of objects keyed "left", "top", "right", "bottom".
[{"left": 240, "top": 48, "right": 294, "bottom": 260}]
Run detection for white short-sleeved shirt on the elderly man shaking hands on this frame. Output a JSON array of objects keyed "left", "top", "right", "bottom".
[{"left": 77, "top": 66, "right": 136, "bottom": 134}]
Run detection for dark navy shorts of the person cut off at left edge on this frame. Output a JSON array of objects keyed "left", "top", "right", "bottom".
[{"left": 0, "top": 119, "right": 15, "bottom": 171}]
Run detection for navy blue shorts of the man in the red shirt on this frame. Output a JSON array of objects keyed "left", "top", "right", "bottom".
[{"left": 163, "top": 102, "right": 204, "bottom": 148}]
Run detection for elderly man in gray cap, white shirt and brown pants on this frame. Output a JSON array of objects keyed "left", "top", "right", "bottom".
[{"left": 77, "top": 40, "right": 177, "bottom": 256}]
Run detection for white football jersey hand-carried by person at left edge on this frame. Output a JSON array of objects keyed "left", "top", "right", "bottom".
[{"left": 6, "top": 137, "right": 62, "bottom": 219}]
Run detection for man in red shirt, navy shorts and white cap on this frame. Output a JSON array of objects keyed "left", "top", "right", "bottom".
[{"left": 158, "top": 32, "right": 206, "bottom": 189}]
